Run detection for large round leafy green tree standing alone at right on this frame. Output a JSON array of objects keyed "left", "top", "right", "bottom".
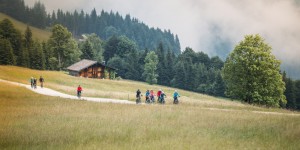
[{"left": 223, "top": 35, "right": 286, "bottom": 107}]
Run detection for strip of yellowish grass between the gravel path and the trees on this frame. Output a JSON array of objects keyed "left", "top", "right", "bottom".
[{"left": 0, "top": 65, "right": 298, "bottom": 112}]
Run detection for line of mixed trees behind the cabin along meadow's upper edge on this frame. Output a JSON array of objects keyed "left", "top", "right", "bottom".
[{"left": 0, "top": 19, "right": 224, "bottom": 96}]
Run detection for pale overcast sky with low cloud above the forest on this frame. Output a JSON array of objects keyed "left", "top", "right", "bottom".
[{"left": 25, "top": 0, "right": 300, "bottom": 76}]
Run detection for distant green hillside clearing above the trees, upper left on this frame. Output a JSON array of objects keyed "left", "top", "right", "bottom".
[{"left": 0, "top": 13, "right": 51, "bottom": 41}]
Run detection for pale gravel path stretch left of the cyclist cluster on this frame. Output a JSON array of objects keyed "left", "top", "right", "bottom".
[{"left": 0, "top": 79, "right": 135, "bottom": 104}]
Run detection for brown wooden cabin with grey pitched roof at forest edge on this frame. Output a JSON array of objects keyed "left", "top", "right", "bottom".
[{"left": 67, "top": 59, "right": 116, "bottom": 79}]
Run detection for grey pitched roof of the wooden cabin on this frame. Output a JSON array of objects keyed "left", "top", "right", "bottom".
[{"left": 67, "top": 59, "right": 116, "bottom": 72}]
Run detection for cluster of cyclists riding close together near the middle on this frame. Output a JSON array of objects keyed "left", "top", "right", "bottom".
[{"left": 136, "top": 89, "right": 180, "bottom": 104}]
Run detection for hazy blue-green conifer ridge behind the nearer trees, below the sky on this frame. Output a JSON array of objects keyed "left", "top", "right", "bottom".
[{"left": 0, "top": 0, "right": 180, "bottom": 54}]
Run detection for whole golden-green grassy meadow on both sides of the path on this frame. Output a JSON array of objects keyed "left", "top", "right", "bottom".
[{"left": 0, "top": 66, "right": 300, "bottom": 150}]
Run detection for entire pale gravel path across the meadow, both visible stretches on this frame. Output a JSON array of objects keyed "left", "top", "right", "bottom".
[{"left": 0, "top": 79, "right": 300, "bottom": 116}]
